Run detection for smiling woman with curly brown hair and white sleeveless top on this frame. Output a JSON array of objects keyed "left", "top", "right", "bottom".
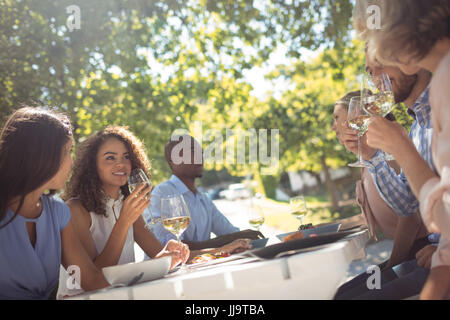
[{"left": 58, "top": 126, "right": 189, "bottom": 298}]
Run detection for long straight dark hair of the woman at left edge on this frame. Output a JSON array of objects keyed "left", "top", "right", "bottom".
[{"left": 0, "top": 107, "right": 72, "bottom": 229}]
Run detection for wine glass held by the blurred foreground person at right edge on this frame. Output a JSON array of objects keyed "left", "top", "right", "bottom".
[{"left": 361, "top": 73, "right": 395, "bottom": 161}]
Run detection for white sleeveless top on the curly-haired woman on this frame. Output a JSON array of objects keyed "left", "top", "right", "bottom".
[{"left": 57, "top": 193, "right": 135, "bottom": 299}]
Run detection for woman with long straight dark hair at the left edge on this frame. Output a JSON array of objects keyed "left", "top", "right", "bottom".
[{"left": 0, "top": 107, "right": 109, "bottom": 299}]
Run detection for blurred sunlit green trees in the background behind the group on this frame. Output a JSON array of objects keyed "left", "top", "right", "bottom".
[{"left": 0, "top": 0, "right": 409, "bottom": 225}]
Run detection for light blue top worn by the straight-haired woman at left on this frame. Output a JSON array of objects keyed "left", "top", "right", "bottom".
[{"left": 0, "top": 196, "right": 71, "bottom": 300}]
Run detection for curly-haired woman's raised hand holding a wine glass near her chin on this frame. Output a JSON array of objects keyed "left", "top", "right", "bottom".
[{"left": 118, "top": 184, "right": 152, "bottom": 227}]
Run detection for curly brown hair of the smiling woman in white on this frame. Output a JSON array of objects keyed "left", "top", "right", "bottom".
[{"left": 62, "top": 126, "right": 150, "bottom": 216}]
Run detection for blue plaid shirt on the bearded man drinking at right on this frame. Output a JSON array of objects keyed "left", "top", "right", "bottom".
[{"left": 365, "top": 87, "right": 435, "bottom": 216}]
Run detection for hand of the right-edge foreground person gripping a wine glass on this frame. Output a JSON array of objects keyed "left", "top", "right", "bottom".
[{"left": 366, "top": 117, "right": 412, "bottom": 158}]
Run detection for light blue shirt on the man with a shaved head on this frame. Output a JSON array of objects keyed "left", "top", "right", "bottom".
[{"left": 145, "top": 175, "right": 239, "bottom": 245}]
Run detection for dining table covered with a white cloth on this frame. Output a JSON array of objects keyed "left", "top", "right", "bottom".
[{"left": 67, "top": 229, "right": 370, "bottom": 300}]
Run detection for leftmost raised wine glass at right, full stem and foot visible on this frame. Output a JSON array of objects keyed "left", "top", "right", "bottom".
[{"left": 347, "top": 97, "right": 370, "bottom": 168}]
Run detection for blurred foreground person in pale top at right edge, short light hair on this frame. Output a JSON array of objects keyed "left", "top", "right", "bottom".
[{"left": 355, "top": 0, "right": 450, "bottom": 299}]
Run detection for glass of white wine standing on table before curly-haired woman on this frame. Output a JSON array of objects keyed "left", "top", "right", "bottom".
[{"left": 161, "top": 195, "right": 191, "bottom": 269}]
